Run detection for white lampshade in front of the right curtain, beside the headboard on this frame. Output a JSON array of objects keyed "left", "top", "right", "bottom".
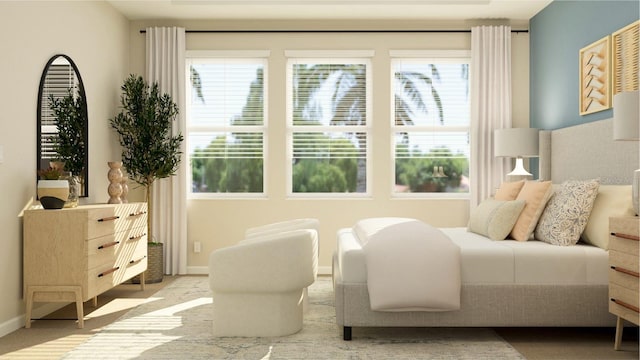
[{"left": 493, "top": 128, "right": 538, "bottom": 158}]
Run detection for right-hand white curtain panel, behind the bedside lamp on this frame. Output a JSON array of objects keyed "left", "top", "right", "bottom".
[{"left": 469, "top": 26, "right": 512, "bottom": 209}]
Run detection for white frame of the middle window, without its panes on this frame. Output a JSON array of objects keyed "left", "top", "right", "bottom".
[{"left": 285, "top": 50, "right": 375, "bottom": 199}]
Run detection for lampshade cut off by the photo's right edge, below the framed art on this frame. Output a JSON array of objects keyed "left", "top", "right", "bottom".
[{"left": 613, "top": 90, "right": 640, "bottom": 140}]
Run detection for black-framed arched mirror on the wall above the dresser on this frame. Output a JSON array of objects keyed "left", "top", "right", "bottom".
[{"left": 37, "top": 54, "right": 89, "bottom": 197}]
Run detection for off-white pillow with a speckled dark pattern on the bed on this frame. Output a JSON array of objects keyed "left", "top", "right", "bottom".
[{"left": 534, "top": 180, "right": 600, "bottom": 246}]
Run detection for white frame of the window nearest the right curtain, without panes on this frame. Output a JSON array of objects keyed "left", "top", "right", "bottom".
[{"left": 389, "top": 50, "right": 473, "bottom": 200}]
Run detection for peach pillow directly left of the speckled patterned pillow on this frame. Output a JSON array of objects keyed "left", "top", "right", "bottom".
[{"left": 511, "top": 181, "right": 553, "bottom": 241}]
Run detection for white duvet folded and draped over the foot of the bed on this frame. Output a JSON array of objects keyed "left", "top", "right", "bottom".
[{"left": 353, "top": 218, "right": 461, "bottom": 311}]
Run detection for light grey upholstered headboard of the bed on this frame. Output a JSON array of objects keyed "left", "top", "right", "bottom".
[{"left": 539, "top": 119, "right": 640, "bottom": 185}]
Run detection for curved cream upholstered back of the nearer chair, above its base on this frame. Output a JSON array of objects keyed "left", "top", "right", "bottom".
[{"left": 209, "top": 229, "right": 318, "bottom": 292}]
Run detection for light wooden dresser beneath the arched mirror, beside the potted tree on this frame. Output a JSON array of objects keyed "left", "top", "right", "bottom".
[{"left": 23, "top": 203, "right": 147, "bottom": 328}]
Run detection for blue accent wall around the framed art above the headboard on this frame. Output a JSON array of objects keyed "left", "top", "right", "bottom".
[{"left": 529, "top": 0, "right": 640, "bottom": 129}]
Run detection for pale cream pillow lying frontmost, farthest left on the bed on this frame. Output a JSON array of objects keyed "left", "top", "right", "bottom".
[{"left": 467, "top": 199, "right": 524, "bottom": 240}]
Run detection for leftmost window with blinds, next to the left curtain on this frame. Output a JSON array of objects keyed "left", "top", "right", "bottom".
[{"left": 187, "top": 54, "right": 268, "bottom": 197}]
